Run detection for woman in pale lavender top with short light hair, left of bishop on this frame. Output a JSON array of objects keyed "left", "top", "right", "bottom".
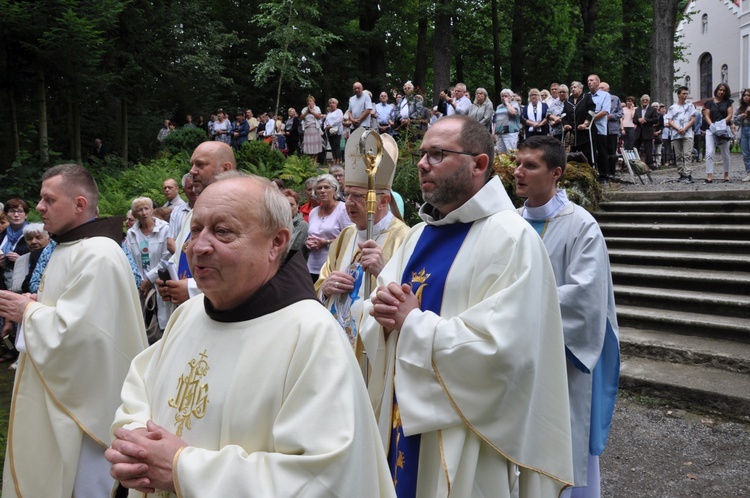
[{"left": 305, "top": 174, "right": 352, "bottom": 282}]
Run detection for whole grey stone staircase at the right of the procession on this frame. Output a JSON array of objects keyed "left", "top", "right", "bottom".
[{"left": 596, "top": 190, "right": 750, "bottom": 420}]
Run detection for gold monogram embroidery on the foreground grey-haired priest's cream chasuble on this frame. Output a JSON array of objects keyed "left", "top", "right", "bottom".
[{"left": 168, "top": 349, "right": 210, "bottom": 436}]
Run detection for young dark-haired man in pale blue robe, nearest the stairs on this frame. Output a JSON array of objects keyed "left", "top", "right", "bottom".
[{"left": 514, "top": 137, "right": 620, "bottom": 498}]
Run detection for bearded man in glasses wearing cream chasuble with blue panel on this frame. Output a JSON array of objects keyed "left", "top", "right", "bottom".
[{"left": 360, "top": 116, "right": 573, "bottom": 498}]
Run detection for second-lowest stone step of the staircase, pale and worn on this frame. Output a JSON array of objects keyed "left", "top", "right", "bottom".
[{"left": 620, "top": 327, "right": 750, "bottom": 374}]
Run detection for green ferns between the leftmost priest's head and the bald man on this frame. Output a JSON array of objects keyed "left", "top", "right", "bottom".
[{"left": 97, "top": 151, "right": 190, "bottom": 216}]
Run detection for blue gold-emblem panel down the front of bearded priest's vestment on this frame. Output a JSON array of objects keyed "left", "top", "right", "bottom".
[{"left": 388, "top": 223, "right": 473, "bottom": 498}]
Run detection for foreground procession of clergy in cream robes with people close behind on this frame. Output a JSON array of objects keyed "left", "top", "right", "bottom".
[{"left": 0, "top": 110, "right": 619, "bottom": 498}]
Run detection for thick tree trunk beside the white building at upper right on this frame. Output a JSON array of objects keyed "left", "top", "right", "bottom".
[{"left": 651, "top": 0, "right": 677, "bottom": 106}]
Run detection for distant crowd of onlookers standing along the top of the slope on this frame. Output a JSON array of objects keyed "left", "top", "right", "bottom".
[{"left": 158, "top": 74, "right": 750, "bottom": 187}]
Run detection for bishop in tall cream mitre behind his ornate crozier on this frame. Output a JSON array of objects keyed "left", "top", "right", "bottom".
[{"left": 315, "top": 130, "right": 409, "bottom": 346}]
